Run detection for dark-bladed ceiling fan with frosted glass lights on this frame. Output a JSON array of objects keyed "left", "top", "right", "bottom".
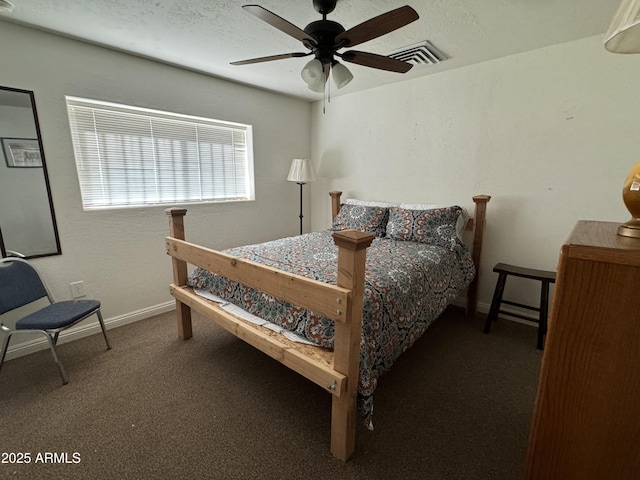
[{"left": 231, "top": 0, "right": 418, "bottom": 92}]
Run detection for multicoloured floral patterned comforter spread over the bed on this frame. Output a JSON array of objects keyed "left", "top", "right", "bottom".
[{"left": 189, "top": 230, "right": 475, "bottom": 427}]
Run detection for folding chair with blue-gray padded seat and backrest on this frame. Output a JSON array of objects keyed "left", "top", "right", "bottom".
[{"left": 0, "top": 257, "right": 111, "bottom": 384}]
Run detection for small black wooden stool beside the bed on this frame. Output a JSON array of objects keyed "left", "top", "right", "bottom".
[{"left": 484, "top": 263, "right": 556, "bottom": 350}]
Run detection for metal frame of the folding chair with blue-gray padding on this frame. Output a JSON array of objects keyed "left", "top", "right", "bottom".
[{"left": 0, "top": 257, "right": 111, "bottom": 385}]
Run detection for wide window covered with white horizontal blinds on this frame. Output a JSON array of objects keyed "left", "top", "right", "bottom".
[{"left": 66, "top": 97, "right": 254, "bottom": 210}]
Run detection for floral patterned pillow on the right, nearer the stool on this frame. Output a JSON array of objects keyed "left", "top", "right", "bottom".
[{"left": 387, "top": 206, "right": 462, "bottom": 250}]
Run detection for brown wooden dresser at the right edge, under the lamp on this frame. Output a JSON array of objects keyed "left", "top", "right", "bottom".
[{"left": 526, "top": 221, "right": 640, "bottom": 480}]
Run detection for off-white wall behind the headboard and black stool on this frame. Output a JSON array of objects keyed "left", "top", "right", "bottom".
[{"left": 310, "top": 36, "right": 640, "bottom": 311}]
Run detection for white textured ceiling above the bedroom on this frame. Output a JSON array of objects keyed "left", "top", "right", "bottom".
[{"left": 0, "top": 0, "right": 620, "bottom": 100}]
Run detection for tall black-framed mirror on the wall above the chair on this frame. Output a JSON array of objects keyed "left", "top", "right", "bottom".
[{"left": 0, "top": 87, "right": 62, "bottom": 258}]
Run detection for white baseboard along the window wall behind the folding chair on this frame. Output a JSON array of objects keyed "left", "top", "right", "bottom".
[{"left": 5, "top": 301, "right": 176, "bottom": 360}]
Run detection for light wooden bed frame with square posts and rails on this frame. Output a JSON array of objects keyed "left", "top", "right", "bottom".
[{"left": 165, "top": 192, "right": 491, "bottom": 461}]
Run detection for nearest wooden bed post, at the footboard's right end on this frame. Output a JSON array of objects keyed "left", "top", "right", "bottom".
[{"left": 331, "top": 230, "right": 375, "bottom": 461}]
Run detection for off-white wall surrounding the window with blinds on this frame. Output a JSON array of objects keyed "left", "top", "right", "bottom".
[{"left": 0, "top": 22, "right": 311, "bottom": 354}]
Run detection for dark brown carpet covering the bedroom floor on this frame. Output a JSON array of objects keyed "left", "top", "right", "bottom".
[{"left": 0, "top": 308, "right": 541, "bottom": 480}]
